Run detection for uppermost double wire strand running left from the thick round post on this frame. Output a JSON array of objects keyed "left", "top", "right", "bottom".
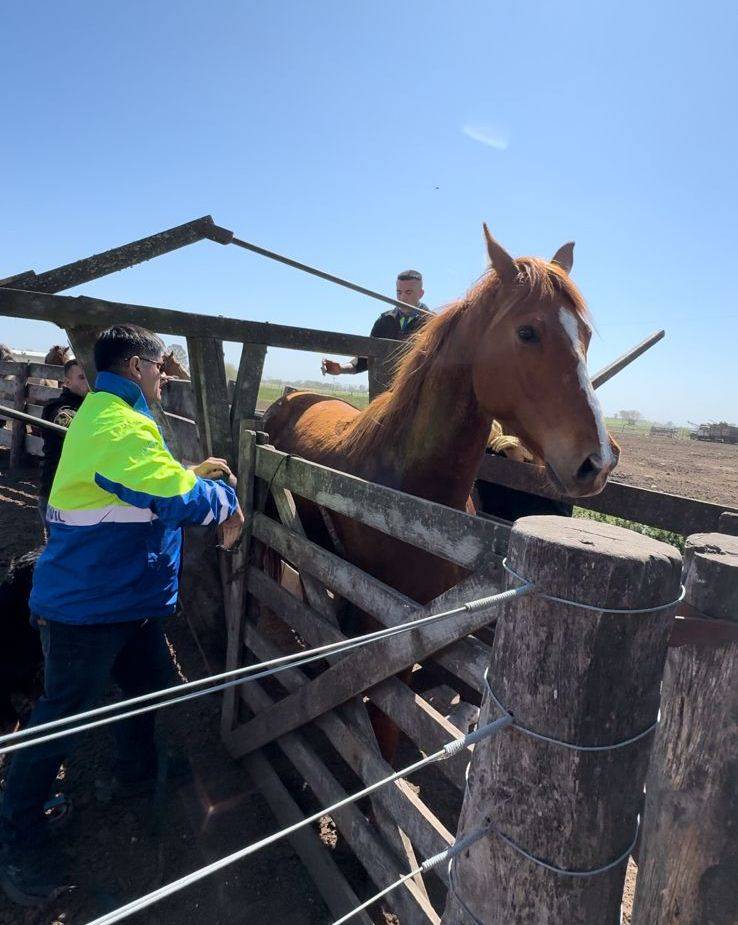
[{"left": 0, "top": 584, "right": 532, "bottom": 755}]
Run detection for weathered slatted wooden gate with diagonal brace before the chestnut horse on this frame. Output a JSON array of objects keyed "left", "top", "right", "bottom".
[{"left": 216, "top": 431, "right": 509, "bottom": 923}]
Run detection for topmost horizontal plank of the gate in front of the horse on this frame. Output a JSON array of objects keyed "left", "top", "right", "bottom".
[{"left": 256, "top": 447, "right": 510, "bottom": 569}]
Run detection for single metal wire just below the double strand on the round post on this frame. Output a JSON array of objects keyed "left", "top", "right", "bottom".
[{"left": 79, "top": 716, "right": 511, "bottom": 925}]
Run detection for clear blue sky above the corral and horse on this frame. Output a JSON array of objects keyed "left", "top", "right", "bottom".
[{"left": 0, "top": 0, "right": 738, "bottom": 422}]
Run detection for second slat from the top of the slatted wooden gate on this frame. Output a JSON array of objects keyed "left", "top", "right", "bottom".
[{"left": 254, "top": 514, "right": 492, "bottom": 691}]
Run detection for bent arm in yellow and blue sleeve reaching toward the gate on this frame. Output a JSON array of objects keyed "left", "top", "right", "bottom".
[{"left": 95, "top": 422, "right": 239, "bottom": 527}]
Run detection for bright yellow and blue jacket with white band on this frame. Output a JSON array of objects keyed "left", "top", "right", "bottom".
[{"left": 30, "top": 372, "right": 237, "bottom": 623}]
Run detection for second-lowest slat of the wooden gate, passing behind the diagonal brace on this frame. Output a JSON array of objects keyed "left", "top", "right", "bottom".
[{"left": 239, "top": 682, "right": 439, "bottom": 925}]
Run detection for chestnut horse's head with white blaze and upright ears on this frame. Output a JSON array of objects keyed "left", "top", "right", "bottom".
[{"left": 471, "top": 225, "right": 620, "bottom": 497}]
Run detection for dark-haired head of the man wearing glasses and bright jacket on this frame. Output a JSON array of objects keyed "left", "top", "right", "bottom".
[{"left": 95, "top": 324, "right": 164, "bottom": 403}]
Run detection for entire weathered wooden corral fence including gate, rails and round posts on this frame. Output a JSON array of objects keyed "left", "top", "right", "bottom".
[{"left": 0, "top": 226, "right": 738, "bottom": 925}]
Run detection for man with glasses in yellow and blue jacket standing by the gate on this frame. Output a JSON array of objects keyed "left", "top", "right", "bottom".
[{"left": 0, "top": 324, "right": 243, "bottom": 905}]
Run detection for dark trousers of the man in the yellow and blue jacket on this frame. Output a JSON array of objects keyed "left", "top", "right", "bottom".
[{"left": 2, "top": 619, "right": 172, "bottom": 844}]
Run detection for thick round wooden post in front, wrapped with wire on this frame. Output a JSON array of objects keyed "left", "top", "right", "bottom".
[{"left": 443, "top": 517, "right": 681, "bottom": 925}]
